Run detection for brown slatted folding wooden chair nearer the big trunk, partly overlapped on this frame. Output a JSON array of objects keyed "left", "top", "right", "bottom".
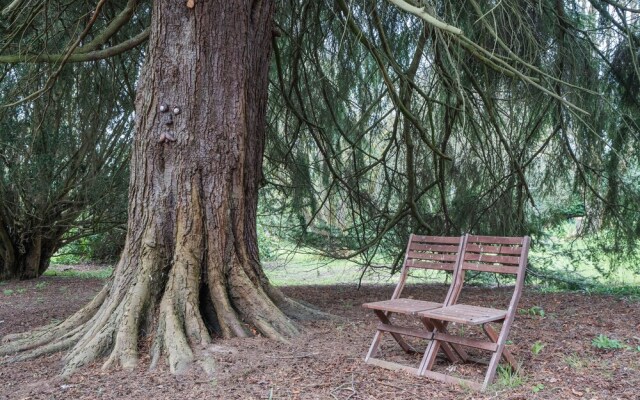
[{"left": 362, "top": 234, "right": 466, "bottom": 374}]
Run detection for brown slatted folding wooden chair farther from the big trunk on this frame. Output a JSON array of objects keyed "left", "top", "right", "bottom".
[{"left": 418, "top": 235, "right": 530, "bottom": 390}]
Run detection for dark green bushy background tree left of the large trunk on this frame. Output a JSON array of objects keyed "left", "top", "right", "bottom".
[{"left": 0, "top": 59, "right": 137, "bottom": 279}]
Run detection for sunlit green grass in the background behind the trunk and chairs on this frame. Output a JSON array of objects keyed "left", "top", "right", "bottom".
[{"left": 33, "top": 223, "right": 640, "bottom": 296}]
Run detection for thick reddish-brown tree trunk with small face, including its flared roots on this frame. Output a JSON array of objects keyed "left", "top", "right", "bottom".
[{"left": 0, "top": 0, "right": 320, "bottom": 374}]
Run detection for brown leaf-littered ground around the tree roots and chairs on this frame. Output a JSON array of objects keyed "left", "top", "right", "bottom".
[{"left": 0, "top": 266, "right": 640, "bottom": 400}]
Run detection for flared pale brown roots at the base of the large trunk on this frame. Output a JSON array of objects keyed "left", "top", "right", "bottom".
[{"left": 0, "top": 225, "right": 329, "bottom": 376}]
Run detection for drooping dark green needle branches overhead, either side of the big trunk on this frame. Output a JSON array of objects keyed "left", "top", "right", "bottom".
[{"left": 0, "top": 0, "right": 640, "bottom": 282}]
